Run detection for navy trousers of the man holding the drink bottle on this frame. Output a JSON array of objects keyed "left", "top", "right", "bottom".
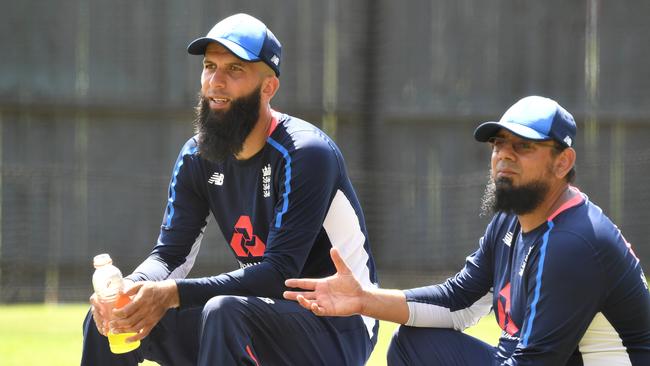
[{"left": 81, "top": 296, "right": 378, "bottom": 366}]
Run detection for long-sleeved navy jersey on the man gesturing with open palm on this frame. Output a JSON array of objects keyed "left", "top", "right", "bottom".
[{"left": 405, "top": 188, "right": 650, "bottom": 366}]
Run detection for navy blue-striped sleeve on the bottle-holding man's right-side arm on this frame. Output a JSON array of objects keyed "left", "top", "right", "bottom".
[{"left": 177, "top": 134, "right": 341, "bottom": 306}]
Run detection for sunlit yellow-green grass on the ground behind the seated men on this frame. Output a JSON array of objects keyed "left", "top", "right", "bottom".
[{"left": 0, "top": 304, "right": 500, "bottom": 366}]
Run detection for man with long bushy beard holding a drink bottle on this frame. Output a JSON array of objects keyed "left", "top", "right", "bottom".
[{"left": 82, "top": 14, "right": 378, "bottom": 366}]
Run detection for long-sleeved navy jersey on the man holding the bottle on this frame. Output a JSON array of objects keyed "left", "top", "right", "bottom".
[{"left": 130, "top": 112, "right": 377, "bottom": 335}]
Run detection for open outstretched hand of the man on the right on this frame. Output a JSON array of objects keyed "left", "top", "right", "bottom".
[{"left": 284, "top": 248, "right": 364, "bottom": 316}]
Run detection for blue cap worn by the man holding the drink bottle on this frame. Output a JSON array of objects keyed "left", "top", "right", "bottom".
[{"left": 187, "top": 14, "right": 282, "bottom": 76}]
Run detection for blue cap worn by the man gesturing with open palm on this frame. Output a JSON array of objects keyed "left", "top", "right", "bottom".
[{"left": 474, "top": 96, "right": 576, "bottom": 147}]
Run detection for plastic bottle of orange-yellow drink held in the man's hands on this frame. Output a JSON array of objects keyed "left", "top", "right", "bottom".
[{"left": 93, "top": 254, "right": 140, "bottom": 353}]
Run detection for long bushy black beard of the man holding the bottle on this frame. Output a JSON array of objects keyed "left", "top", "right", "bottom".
[{"left": 194, "top": 87, "right": 261, "bottom": 162}]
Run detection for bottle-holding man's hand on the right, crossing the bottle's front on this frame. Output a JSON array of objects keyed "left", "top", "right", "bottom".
[{"left": 110, "top": 280, "right": 179, "bottom": 342}]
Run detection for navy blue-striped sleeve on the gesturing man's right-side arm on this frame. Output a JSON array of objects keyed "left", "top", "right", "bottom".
[{"left": 504, "top": 230, "right": 606, "bottom": 366}]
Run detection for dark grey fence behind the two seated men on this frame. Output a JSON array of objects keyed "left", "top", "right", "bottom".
[{"left": 0, "top": 0, "right": 650, "bottom": 302}]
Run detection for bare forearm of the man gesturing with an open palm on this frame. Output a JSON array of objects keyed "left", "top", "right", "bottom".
[{"left": 361, "top": 288, "right": 409, "bottom": 324}]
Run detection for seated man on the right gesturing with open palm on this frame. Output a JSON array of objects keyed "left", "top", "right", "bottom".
[{"left": 285, "top": 96, "right": 650, "bottom": 366}]
